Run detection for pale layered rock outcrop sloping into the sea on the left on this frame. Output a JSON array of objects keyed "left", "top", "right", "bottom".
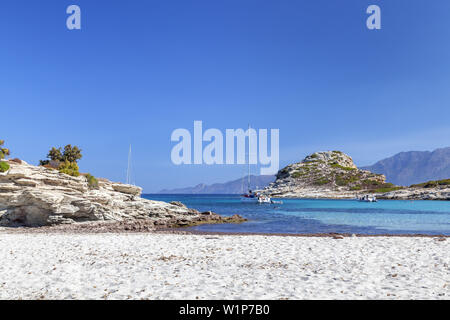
[{"left": 0, "top": 161, "right": 244, "bottom": 227}]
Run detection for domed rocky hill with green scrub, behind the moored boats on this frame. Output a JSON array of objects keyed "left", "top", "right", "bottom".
[{"left": 264, "top": 151, "right": 395, "bottom": 198}]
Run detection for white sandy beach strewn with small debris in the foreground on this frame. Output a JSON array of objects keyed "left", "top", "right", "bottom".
[{"left": 0, "top": 232, "right": 450, "bottom": 299}]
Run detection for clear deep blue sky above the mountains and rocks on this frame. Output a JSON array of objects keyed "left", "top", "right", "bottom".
[{"left": 0, "top": 0, "right": 450, "bottom": 192}]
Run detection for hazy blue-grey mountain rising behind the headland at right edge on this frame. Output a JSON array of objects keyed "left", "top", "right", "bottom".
[{"left": 361, "top": 147, "right": 450, "bottom": 186}]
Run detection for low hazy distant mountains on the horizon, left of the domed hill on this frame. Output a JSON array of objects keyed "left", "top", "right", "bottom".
[{"left": 159, "top": 175, "right": 275, "bottom": 194}]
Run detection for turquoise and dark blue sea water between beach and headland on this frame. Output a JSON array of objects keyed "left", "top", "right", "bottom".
[{"left": 144, "top": 195, "right": 450, "bottom": 235}]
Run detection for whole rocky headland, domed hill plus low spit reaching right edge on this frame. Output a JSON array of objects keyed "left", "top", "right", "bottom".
[{"left": 261, "top": 151, "right": 450, "bottom": 200}]
